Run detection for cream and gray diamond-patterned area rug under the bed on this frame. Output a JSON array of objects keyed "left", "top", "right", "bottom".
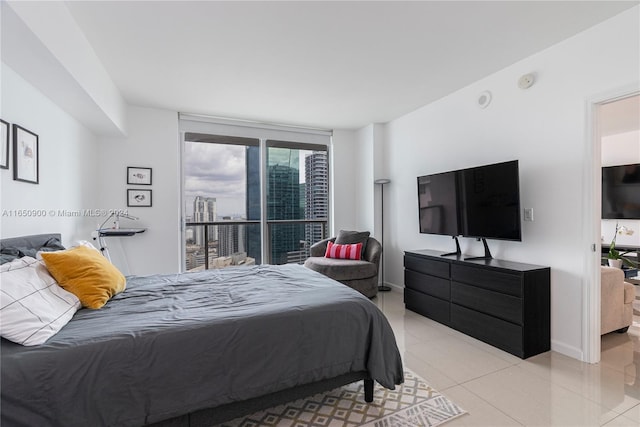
[{"left": 220, "top": 370, "right": 466, "bottom": 427}]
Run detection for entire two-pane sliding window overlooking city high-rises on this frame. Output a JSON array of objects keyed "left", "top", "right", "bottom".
[{"left": 181, "top": 117, "right": 329, "bottom": 271}]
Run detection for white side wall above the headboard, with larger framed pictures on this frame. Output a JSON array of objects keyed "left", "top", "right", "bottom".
[{"left": 0, "top": 63, "right": 100, "bottom": 246}]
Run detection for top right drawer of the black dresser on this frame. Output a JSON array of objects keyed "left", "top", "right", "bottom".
[{"left": 451, "top": 264, "right": 522, "bottom": 297}]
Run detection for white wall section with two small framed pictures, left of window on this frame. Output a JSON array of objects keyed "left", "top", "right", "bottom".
[{"left": 99, "top": 106, "right": 181, "bottom": 275}]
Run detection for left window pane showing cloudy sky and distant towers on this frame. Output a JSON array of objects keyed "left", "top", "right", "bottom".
[{"left": 183, "top": 133, "right": 262, "bottom": 271}]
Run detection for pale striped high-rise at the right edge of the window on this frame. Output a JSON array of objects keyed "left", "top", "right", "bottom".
[{"left": 304, "top": 151, "right": 329, "bottom": 251}]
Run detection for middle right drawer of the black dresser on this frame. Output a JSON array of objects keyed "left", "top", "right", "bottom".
[{"left": 451, "top": 282, "right": 522, "bottom": 325}]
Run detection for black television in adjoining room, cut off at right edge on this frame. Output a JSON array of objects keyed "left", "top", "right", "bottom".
[{"left": 602, "top": 163, "right": 640, "bottom": 219}]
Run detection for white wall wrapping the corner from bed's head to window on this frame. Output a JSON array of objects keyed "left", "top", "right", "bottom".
[{"left": 0, "top": 64, "right": 180, "bottom": 274}]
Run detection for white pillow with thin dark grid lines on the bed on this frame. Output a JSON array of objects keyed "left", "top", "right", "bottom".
[{"left": 0, "top": 257, "right": 80, "bottom": 346}]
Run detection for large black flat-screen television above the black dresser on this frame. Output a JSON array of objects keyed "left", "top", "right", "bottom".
[{"left": 418, "top": 160, "right": 522, "bottom": 241}]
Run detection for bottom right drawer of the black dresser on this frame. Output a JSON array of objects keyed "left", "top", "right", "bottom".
[{"left": 451, "top": 304, "right": 525, "bottom": 358}]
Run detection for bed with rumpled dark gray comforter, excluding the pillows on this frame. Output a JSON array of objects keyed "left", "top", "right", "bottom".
[{"left": 0, "top": 235, "right": 403, "bottom": 427}]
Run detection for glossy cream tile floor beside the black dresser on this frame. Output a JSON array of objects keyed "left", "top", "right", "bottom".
[{"left": 373, "top": 289, "right": 640, "bottom": 427}]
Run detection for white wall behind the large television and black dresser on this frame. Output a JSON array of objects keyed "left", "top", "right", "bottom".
[{"left": 384, "top": 7, "right": 640, "bottom": 359}]
